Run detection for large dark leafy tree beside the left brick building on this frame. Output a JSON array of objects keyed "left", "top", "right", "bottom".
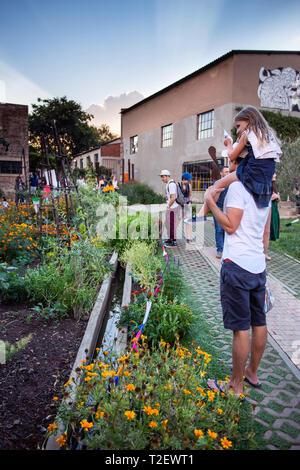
[{"left": 29, "top": 96, "right": 99, "bottom": 161}]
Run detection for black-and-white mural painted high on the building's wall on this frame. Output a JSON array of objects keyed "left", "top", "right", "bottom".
[{"left": 257, "top": 67, "right": 300, "bottom": 111}]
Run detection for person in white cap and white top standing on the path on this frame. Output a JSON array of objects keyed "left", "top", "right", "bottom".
[{"left": 159, "top": 170, "right": 180, "bottom": 248}]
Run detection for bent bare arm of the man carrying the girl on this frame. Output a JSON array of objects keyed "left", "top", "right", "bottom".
[{"left": 205, "top": 187, "right": 244, "bottom": 235}]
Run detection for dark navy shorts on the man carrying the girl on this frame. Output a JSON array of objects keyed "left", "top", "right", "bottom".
[{"left": 220, "top": 261, "right": 266, "bottom": 331}]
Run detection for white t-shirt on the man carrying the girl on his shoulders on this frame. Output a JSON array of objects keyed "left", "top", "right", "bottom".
[{"left": 222, "top": 181, "right": 270, "bottom": 274}]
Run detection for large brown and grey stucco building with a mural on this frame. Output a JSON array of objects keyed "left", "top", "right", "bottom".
[{"left": 121, "top": 50, "right": 300, "bottom": 200}]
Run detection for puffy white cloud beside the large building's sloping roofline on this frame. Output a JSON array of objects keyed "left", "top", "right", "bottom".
[{"left": 86, "top": 91, "right": 144, "bottom": 134}]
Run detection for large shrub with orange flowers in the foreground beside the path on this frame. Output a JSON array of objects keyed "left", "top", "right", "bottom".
[{"left": 48, "top": 337, "right": 252, "bottom": 450}]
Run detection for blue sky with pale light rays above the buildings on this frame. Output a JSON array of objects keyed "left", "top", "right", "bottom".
[{"left": 0, "top": 0, "right": 300, "bottom": 131}]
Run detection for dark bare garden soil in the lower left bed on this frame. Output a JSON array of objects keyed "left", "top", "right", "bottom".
[{"left": 0, "top": 305, "right": 87, "bottom": 450}]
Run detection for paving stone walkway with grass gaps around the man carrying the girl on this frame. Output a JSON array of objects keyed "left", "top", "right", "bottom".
[{"left": 172, "top": 221, "right": 300, "bottom": 450}]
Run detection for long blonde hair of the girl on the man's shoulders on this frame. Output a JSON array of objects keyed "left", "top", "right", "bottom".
[{"left": 234, "top": 106, "right": 280, "bottom": 146}]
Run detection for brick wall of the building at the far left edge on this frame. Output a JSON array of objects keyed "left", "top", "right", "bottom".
[{"left": 0, "top": 103, "right": 29, "bottom": 199}]
